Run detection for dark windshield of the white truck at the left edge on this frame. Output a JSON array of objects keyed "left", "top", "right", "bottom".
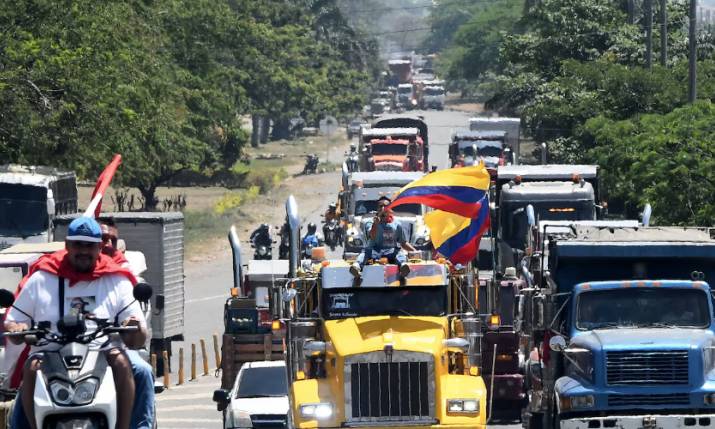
[{"left": 0, "top": 183, "right": 49, "bottom": 238}]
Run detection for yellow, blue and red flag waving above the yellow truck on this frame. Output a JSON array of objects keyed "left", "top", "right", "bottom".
[{"left": 390, "top": 163, "right": 490, "bottom": 264}]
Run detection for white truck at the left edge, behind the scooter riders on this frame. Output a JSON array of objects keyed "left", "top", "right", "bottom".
[{"left": 0, "top": 164, "right": 77, "bottom": 249}]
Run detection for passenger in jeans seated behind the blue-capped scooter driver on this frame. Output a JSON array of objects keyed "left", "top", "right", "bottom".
[{"left": 100, "top": 219, "right": 155, "bottom": 429}]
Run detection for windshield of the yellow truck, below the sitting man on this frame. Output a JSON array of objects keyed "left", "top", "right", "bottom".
[{"left": 323, "top": 286, "right": 447, "bottom": 319}]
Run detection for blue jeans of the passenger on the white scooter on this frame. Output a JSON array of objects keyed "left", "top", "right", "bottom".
[{"left": 10, "top": 350, "right": 155, "bottom": 429}]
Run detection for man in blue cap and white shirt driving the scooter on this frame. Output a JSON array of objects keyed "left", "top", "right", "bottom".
[{"left": 5, "top": 217, "right": 147, "bottom": 429}]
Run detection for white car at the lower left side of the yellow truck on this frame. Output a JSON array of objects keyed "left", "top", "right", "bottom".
[{"left": 214, "top": 361, "right": 290, "bottom": 429}]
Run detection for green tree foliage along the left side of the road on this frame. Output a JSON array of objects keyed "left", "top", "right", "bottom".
[{"left": 0, "top": 0, "right": 374, "bottom": 206}]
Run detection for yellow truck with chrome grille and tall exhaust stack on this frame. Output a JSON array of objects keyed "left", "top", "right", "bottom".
[{"left": 283, "top": 197, "right": 487, "bottom": 429}]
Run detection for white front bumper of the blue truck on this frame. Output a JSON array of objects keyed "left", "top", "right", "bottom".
[{"left": 561, "top": 414, "right": 715, "bottom": 429}]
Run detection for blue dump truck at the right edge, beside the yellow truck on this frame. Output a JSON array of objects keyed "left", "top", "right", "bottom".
[{"left": 520, "top": 223, "right": 715, "bottom": 429}]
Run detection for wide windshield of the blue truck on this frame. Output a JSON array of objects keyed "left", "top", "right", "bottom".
[{"left": 576, "top": 288, "right": 710, "bottom": 330}]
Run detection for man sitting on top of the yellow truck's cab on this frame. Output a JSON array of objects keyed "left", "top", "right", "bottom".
[{"left": 350, "top": 196, "right": 415, "bottom": 280}]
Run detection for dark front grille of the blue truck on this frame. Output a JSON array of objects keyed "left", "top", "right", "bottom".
[{"left": 606, "top": 350, "right": 688, "bottom": 385}]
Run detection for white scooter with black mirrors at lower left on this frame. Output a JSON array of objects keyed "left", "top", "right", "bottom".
[{"left": 0, "top": 283, "right": 152, "bottom": 428}]
